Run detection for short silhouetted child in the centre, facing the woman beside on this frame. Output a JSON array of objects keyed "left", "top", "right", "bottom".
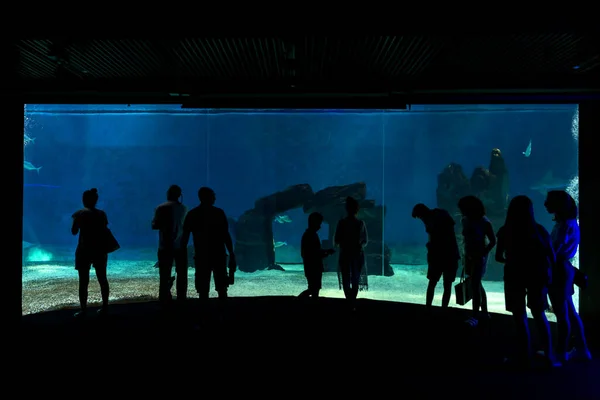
[{"left": 298, "top": 212, "right": 335, "bottom": 299}]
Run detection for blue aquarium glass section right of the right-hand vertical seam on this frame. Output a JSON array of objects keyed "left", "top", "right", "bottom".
[{"left": 376, "top": 105, "right": 579, "bottom": 320}]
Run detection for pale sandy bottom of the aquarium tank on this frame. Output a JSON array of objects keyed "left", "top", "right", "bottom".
[{"left": 22, "top": 260, "right": 579, "bottom": 321}]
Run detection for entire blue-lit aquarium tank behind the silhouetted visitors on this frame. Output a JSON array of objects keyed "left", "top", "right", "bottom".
[{"left": 22, "top": 104, "right": 578, "bottom": 317}]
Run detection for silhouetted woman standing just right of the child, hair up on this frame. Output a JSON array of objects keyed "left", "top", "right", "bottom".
[{"left": 334, "top": 197, "right": 369, "bottom": 311}]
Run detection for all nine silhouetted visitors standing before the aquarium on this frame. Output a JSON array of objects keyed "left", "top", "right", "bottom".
[{"left": 71, "top": 185, "right": 591, "bottom": 366}]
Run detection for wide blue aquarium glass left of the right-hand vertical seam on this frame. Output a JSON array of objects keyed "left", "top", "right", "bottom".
[{"left": 23, "top": 105, "right": 391, "bottom": 313}]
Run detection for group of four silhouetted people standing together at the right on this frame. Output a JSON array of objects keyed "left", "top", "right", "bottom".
[{"left": 412, "top": 190, "right": 591, "bottom": 366}]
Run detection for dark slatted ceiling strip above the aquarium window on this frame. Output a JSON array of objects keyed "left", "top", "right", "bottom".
[{"left": 2, "top": 33, "right": 600, "bottom": 103}]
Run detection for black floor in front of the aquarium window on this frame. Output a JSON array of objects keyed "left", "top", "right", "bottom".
[{"left": 18, "top": 297, "right": 600, "bottom": 399}]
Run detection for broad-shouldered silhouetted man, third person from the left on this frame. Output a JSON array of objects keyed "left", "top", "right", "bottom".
[{"left": 182, "top": 187, "right": 237, "bottom": 316}]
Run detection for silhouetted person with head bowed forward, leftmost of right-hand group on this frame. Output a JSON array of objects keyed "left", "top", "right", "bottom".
[{"left": 412, "top": 203, "right": 460, "bottom": 310}]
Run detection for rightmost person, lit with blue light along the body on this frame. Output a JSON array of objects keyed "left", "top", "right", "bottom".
[{"left": 544, "top": 190, "right": 592, "bottom": 361}]
